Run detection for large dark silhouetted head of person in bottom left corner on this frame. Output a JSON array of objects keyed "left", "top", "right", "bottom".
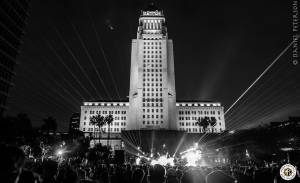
[{"left": 0, "top": 145, "right": 25, "bottom": 183}]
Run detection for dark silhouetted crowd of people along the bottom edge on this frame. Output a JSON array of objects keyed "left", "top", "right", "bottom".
[{"left": 0, "top": 145, "right": 300, "bottom": 183}]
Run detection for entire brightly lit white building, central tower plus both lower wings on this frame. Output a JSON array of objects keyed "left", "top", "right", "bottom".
[{"left": 80, "top": 7, "right": 225, "bottom": 137}]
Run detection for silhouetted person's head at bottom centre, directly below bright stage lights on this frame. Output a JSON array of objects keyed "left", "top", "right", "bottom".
[{"left": 148, "top": 164, "right": 166, "bottom": 183}]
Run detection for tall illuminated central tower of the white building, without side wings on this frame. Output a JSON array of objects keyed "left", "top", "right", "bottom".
[{"left": 127, "top": 5, "right": 177, "bottom": 130}]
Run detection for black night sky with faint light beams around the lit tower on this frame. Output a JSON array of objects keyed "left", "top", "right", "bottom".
[{"left": 7, "top": 0, "right": 300, "bottom": 130}]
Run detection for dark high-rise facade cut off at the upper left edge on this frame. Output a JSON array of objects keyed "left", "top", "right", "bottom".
[{"left": 0, "top": 0, "right": 29, "bottom": 116}]
